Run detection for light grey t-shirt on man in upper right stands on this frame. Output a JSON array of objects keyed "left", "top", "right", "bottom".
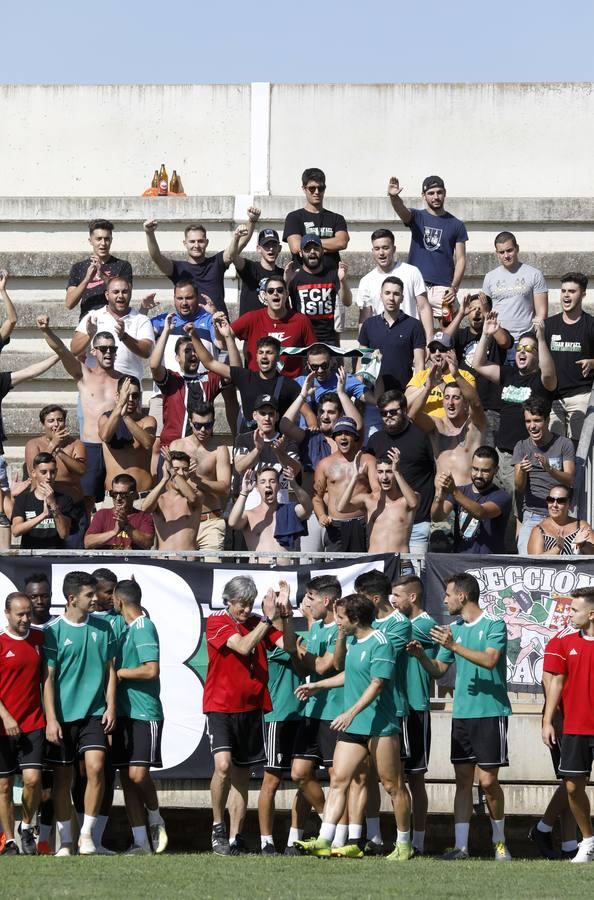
[{"left": 483, "top": 263, "right": 548, "bottom": 338}]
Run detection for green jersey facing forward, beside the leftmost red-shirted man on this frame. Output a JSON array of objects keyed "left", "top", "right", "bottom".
[{"left": 43, "top": 615, "right": 116, "bottom": 722}]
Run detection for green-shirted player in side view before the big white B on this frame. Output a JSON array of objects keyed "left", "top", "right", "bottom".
[{"left": 112, "top": 580, "right": 167, "bottom": 853}]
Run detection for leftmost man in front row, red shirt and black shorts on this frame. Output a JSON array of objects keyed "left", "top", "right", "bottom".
[{"left": 0, "top": 592, "right": 45, "bottom": 856}]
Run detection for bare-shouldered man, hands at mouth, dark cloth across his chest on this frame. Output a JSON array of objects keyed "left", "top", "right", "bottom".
[{"left": 98, "top": 375, "right": 157, "bottom": 497}]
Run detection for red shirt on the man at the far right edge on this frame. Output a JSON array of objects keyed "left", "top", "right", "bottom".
[{"left": 544, "top": 631, "right": 594, "bottom": 735}]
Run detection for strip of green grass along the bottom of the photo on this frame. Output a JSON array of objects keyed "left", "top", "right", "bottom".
[{"left": 0, "top": 854, "right": 594, "bottom": 900}]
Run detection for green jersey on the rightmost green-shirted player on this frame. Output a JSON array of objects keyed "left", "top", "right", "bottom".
[{"left": 437, "top": 613, "right": 511, "bottom": 719}]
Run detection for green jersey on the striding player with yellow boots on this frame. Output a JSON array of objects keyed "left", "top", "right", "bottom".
[{"left": 344, "top": 629, "right": 400, "bottom": 737}]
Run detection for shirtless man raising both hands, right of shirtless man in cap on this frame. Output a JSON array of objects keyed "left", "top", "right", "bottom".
[{"left": 336, "top": 448, "right": 419, "bottom": 553}]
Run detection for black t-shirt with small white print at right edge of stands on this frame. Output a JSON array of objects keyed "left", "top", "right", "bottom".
[{"left": 545, "top": 313, "right": 594, "bottom": 397}]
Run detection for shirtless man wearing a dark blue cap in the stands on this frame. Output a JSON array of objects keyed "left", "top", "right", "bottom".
[{"left": 313, "top": 416, "right": 369, "bottom": 553}]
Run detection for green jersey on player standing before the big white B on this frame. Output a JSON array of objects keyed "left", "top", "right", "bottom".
[{"left": 116, "top": 614, "right": 163, "bottom": 722}]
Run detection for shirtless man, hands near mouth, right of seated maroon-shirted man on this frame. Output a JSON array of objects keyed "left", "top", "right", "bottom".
[{"left": 141, "top": 447, "right": 202, "bottom": 551}]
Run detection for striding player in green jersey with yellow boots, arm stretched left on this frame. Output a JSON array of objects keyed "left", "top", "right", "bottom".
[{"left": 296, "top": 594, "right": 413, "bottom": 862}]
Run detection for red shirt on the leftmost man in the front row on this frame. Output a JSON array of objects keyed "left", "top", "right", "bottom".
[{"left": 0, "top": 629, "right": 45, "bottom": 735}]
